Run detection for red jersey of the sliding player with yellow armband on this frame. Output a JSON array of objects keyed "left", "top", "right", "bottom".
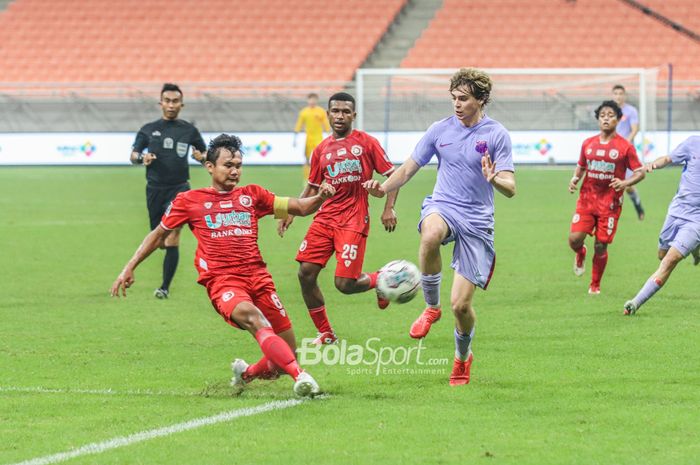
[{"left": 160, "top": 184, "right": 275, "bottom": 284}]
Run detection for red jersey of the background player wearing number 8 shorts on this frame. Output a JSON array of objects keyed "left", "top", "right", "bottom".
[{"left": 577, "top": 134, "right": 642, "bottom": 214}]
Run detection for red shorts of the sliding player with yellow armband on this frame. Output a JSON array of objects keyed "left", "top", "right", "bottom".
[{"left": 207, "top": 268, "right": 292, "bottom": 333}]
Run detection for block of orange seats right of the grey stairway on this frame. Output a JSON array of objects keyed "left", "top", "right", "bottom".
[{"left": 401, "top": 0, "right": 700, "bottom": 80}]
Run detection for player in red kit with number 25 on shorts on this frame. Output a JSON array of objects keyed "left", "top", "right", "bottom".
[{"left": 278, "top": 92, "right": 398, "bottom": 344}]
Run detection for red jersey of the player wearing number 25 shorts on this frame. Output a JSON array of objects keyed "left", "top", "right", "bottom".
[{"left": 309, "top": 130, "right": 394, "bottom": 234}]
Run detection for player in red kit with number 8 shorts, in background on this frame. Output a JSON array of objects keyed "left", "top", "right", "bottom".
[{"left": 569, "top": 100, "right": 644, "bottom": 294}]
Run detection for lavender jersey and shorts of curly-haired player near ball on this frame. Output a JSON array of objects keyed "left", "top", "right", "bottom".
[{"left": 411, "top": 116, "right": 515, "bottom": 289}]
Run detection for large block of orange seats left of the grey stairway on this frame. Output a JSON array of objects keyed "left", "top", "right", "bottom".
[{"left": 0, "top": 0, "right": 407, "bottom": 82}]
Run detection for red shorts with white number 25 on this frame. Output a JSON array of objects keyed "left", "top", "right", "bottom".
[{"left": 296, "top": 221, "right": 367, "bottom": 279}]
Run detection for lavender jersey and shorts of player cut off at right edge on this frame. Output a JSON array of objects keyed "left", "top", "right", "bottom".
[{"left": 659, "top": 136, "right": 700, "bottom": 257}]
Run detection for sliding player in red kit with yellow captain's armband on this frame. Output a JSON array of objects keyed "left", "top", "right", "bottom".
[{"left": 111, "top": 134, "right": 335, "bottom": 396}]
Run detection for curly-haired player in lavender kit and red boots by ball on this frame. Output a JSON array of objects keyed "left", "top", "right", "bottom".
[{"left": 364, "top": 68, "right": 515, "bottom": 386}]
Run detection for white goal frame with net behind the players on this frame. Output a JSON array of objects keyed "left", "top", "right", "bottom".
[{"left": 355, "top": 68, "right": 658, "bottom": 159}]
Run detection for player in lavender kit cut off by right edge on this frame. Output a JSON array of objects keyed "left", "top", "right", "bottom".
[{"left": 625, "top": 136, "right": 700, "bottom": 315}]
